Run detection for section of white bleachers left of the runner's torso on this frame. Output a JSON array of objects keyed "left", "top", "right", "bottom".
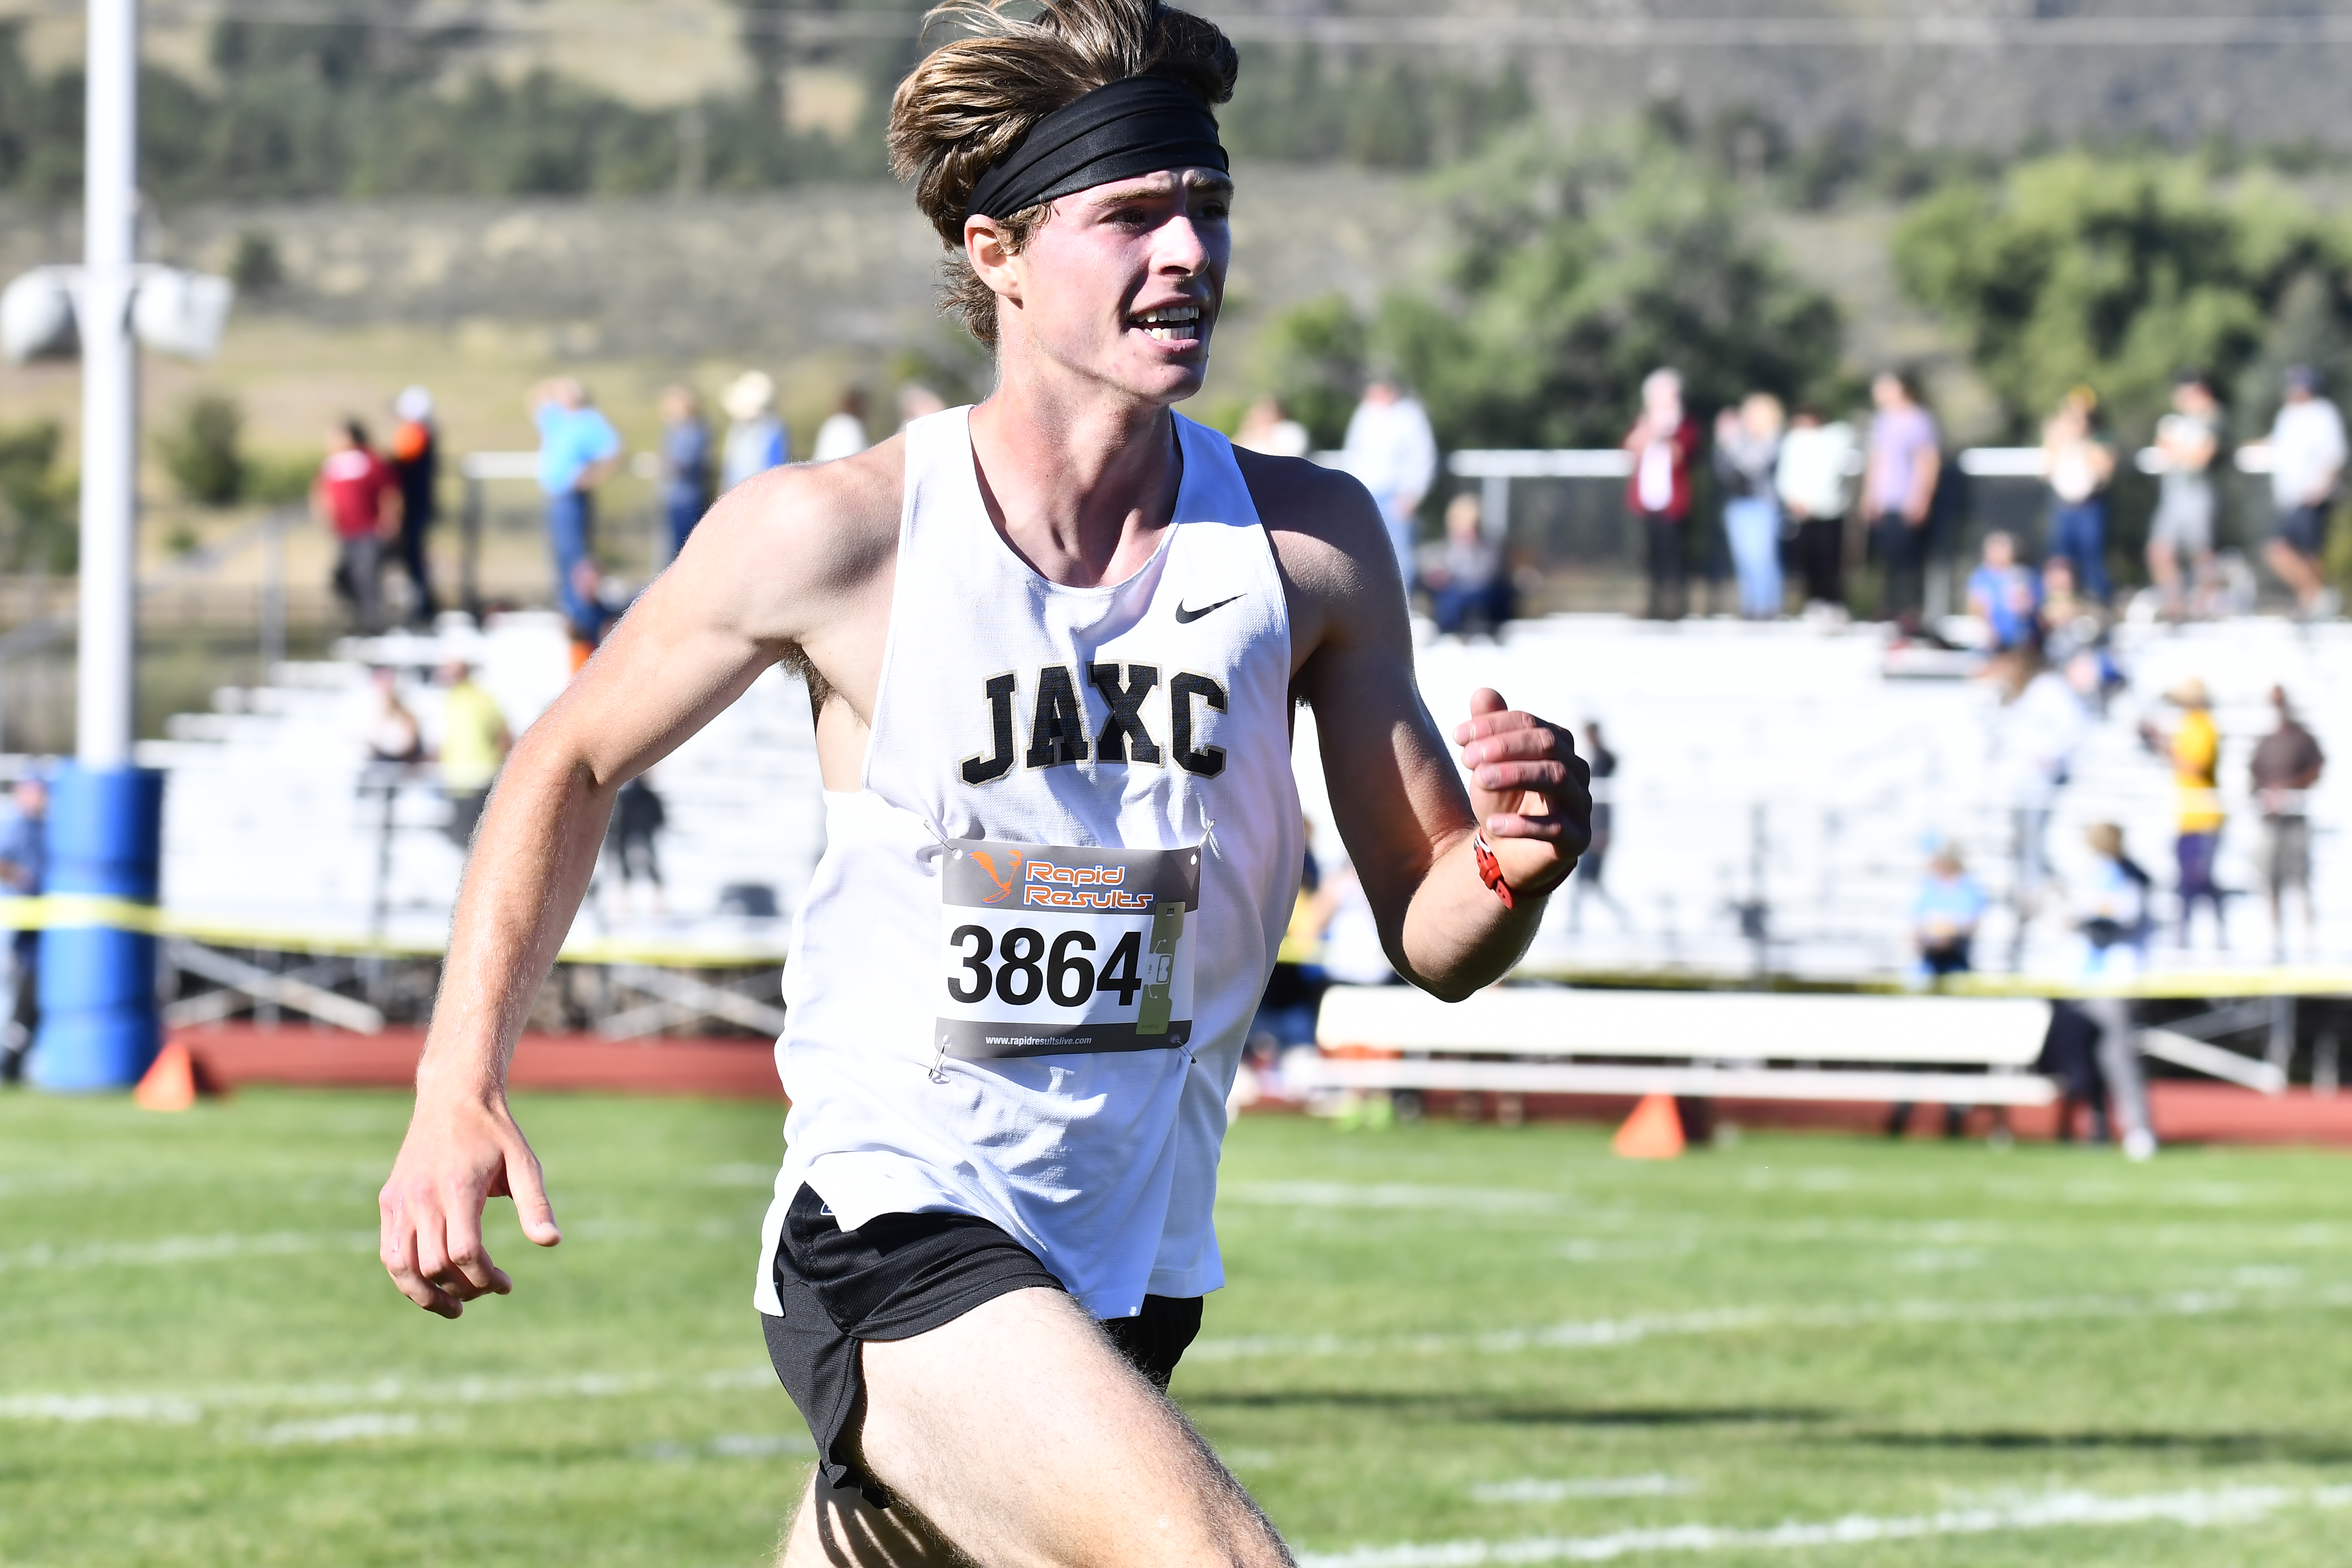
[{"left": 139, "top": 611, "right": 823, "bottom": 964}]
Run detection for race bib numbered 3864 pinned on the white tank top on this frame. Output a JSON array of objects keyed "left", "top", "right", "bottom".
[{"left": 934, "top": 839, "right": 1200, "bottom": 1060}]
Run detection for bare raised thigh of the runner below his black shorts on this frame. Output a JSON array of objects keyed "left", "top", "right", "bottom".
[{"left": 861, "top": 1290, "right": 1289, "bottom": 1568}]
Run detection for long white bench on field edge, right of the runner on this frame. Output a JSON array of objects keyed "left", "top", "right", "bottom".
[{"left": 1284, "top": 985, "right": 2058, "bottom": 1105}]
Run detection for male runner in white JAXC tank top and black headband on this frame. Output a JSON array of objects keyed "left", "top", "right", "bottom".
[{"left": 381, "top": 0, "right": 1590, "bottom": 1568}]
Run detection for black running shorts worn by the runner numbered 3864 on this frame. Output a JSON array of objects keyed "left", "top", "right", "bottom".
[{"left": 760, "top": 1187, "right": 1200, "bottom": 1509}]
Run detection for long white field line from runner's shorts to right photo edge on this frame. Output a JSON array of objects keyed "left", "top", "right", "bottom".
[{"left": 1185, "top": 1286, "right": 2352, "bottom": 1361}]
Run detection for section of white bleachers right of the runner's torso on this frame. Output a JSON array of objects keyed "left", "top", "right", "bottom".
[{"left": 1298, "top": 616, "right": 2352, "bottom": 983}]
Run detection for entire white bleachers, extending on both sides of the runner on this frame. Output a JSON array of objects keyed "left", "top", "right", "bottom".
[{"left": 124, "top": 614, "right": 2352, "bottom": 1020}]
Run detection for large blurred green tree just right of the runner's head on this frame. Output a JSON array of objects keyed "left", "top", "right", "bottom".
[{"left": 1268, "top": 125, "right": 1848, "bottom": 446}]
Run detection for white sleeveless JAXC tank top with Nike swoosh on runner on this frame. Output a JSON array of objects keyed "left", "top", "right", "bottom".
[{"left": 755, "top": 409, "right": 1303, "bottom": 1317}]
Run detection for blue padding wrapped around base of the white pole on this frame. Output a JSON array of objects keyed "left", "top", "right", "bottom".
[{"left": 26, "top": 766, "right": 162, "bottom": 1093}]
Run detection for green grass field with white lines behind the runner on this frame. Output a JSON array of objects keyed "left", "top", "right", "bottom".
[{"left": 0, "top": 1091, "right": 2352, "bottom": 1568}]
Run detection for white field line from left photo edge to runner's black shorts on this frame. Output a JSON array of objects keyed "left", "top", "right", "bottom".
[{"left": 0, "top": 1366, "right": 776, "bottom": 1425}]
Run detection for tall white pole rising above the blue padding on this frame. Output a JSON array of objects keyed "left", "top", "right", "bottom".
[{"left": 75, "top": 0, "right": 139, "bottom": 771}]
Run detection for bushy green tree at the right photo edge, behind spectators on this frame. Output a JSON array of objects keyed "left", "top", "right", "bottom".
[{"left": 1893, "top": 153, "right": 2352, "bottom": 440}]
